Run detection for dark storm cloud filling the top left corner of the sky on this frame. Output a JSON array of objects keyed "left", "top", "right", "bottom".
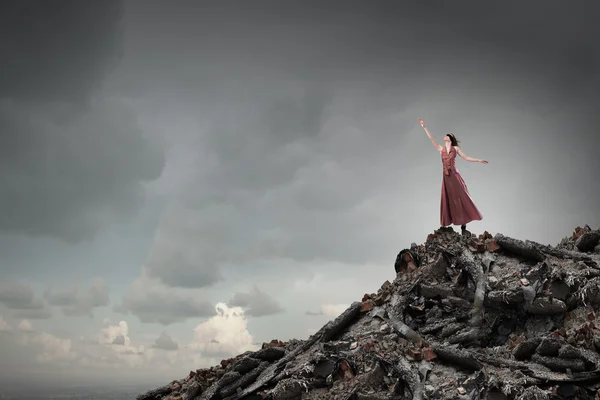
[{"left": 0, "top": 0, "right": 123, "bottom": 103}]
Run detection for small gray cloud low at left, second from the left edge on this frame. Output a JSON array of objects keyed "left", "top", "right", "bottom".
[{"left": 44, "top": 278, "right": 110, "bottom": 316}]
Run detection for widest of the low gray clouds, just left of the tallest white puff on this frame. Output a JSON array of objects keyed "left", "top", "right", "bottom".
[{"left": 114, "top": 277, "right": 215, "bottom": 325}]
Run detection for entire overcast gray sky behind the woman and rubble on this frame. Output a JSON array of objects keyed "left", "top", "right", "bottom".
[{"left": 0, "top": 0, "right": 600, "bottom": 392}]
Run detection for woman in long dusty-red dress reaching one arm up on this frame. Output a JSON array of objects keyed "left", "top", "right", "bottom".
[{"left": 419, "top": 118, "right": 488, "bottom": 233}]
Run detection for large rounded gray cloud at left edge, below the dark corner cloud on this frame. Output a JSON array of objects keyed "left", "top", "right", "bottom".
[{"left": 0, "top": 96, "right": 164, "bottom": 241}]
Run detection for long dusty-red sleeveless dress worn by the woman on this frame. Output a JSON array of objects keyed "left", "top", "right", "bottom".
[{"left": 440, "top": 146, "right": 483, "bottom": 226}]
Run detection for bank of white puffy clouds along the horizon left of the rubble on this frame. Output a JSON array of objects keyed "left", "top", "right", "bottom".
[{"left": 0, "top": 303, "right": 258, "bottom": 382}]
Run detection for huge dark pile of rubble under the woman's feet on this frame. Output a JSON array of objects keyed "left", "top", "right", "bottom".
[{"left": 137, "top": 226, "right": 600, "bottom": 400}]
